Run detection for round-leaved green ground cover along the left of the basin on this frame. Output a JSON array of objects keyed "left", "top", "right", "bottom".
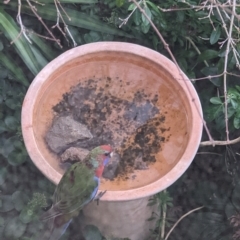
[{"left": 0, "top": 73, "right": 53, "bottom": 240}]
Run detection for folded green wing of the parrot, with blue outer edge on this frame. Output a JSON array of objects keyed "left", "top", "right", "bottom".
[{"left": 53, "top": 163, "right": 99, "bottom": 214}]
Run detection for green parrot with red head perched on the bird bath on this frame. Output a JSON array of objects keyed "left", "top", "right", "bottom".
[{"left": 38, "top": 145, "right": 112, "bottom": 240}]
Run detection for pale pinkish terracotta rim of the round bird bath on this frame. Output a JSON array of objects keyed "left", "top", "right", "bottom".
[{"left": 22, "top": 42, "right": 202, "bottom": 201}]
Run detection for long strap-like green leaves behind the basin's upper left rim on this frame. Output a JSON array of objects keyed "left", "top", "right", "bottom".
[{"left": 0, "top": 0, "right": 132, "bottom": 78}]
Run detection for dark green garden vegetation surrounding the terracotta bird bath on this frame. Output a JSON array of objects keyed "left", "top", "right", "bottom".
[{"left": 0, "top": 0, "right": 240, "bottom": 240}]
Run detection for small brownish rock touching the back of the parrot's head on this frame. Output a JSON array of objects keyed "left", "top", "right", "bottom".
[{"left": 60, "top": 147, "right": 89, "bottom": 162}]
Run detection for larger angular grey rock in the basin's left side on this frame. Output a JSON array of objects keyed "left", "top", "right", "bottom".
[{"left": 46, "top": 116, "right": 93, "bottom": 153}]
